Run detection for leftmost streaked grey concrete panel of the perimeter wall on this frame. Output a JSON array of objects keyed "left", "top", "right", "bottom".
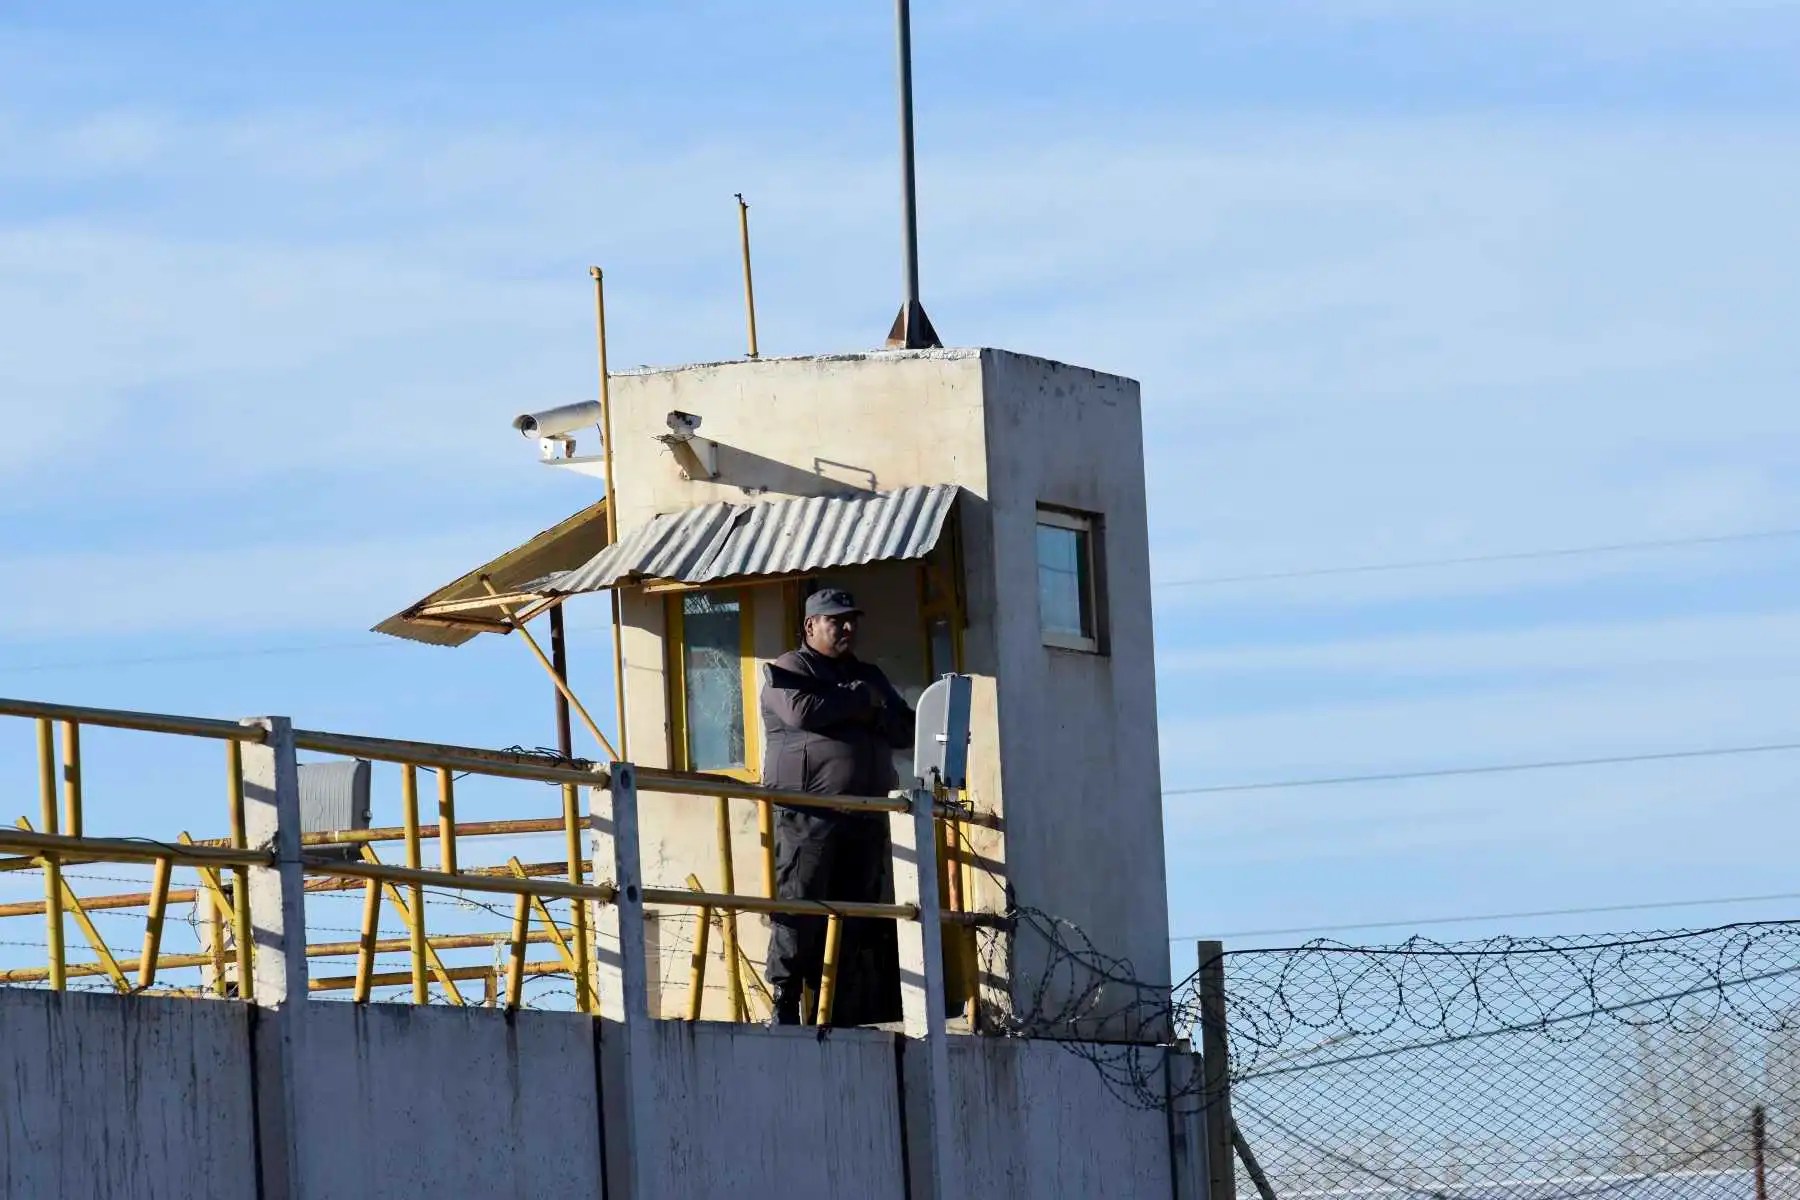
[{"left": 0, "top": 988, "right": 256, "bottom": 1200}]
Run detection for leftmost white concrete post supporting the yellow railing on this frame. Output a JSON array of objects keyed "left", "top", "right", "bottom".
[{"left": 238, "top": 716, "right": 313, "bottom": 1200}]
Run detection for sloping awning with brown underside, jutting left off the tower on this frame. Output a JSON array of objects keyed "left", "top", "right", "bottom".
[{"left": 374, "top": 500, "right": 607, "bottom": 646}]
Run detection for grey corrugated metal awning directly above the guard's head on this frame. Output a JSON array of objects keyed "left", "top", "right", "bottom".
[{"left": 524, "top": 484, "right": 959, "bottom": 596}]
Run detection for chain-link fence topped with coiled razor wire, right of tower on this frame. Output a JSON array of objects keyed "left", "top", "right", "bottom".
[{"left": 1224, "top": 921, "right": 1800, "bottom": 1200}]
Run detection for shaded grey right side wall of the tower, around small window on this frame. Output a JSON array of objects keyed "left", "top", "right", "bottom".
[{"left": 970, "top": 351, "right": 1168, "bottom": 1036}]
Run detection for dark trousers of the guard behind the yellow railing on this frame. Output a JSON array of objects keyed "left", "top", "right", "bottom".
[{"left": 769, "top": 808, "right": 900, "bottom": 1025}]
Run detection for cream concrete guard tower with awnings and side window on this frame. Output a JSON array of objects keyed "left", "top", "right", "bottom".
[{"left": 382, "top": 341, "right": 1168, "bottom": 1040}]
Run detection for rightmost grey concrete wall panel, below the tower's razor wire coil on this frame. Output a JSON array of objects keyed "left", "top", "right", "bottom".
[{"left": 950, "top": 1038, "right": 1174, "bottom": 1200}]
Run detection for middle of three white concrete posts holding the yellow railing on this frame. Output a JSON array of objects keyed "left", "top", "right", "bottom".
[{"left": 589, "top": 763, "right": 653, "bottom": 1200}]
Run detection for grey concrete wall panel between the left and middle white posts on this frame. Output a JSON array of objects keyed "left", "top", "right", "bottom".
[{"left": 299, "top": 1002, "right": 601, "bottom": 1200}]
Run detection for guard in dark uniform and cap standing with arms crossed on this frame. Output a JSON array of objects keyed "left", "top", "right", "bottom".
[{"left": 761, "top": 588, "right": 914, "bottom": 1025}]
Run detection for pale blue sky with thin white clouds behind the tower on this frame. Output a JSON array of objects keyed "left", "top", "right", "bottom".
[{"left": 0, "top": 0, "right": 1800, "bottom": 985}]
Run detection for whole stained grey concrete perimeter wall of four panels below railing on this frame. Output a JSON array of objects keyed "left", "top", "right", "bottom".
[{"left": 0, "top": 988, "right": 1188, "bottom": 1200}]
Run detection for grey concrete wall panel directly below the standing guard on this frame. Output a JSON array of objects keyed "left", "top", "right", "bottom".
[{"left": 643, "top": 1022, "right": 905, "bottom": 1200}]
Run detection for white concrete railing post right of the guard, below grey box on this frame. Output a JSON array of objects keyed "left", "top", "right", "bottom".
[{"left": 889, "top": 788, "right": 963, "bottom": 1200}]
